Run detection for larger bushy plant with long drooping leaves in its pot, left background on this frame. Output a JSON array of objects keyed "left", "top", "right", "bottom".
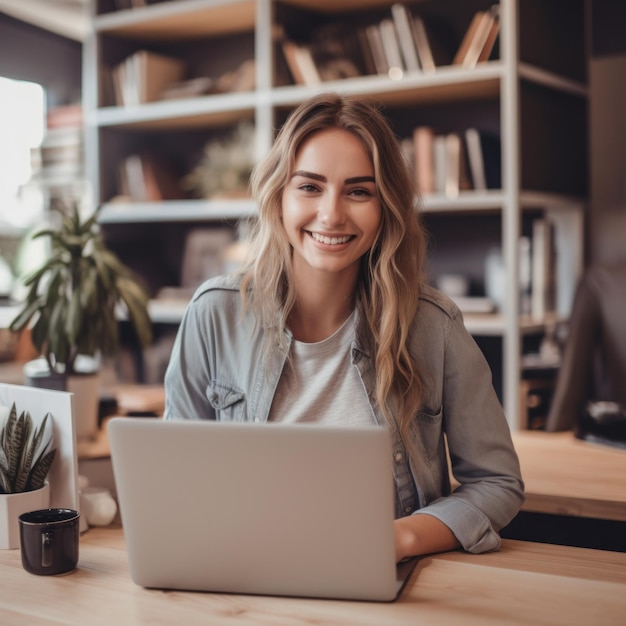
[{"left": 10, "top": 204, "right": 152, "bottom": 438}]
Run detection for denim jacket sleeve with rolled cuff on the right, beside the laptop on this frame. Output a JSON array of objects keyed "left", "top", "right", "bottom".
[{"left": 416, "top": 310, "right": 524, "bottom": 552}]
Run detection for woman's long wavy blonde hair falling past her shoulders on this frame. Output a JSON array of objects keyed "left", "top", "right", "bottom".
[{"left": 241, "top": 93, "right": 426, "bottom": 434}]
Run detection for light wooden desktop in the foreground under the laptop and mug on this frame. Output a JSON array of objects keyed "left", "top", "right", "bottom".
[{"left": 0, "top": 527, "right": 626, "bottom": 626}]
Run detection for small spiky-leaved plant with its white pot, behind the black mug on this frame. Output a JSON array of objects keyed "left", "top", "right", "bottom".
[{"left": 0, "top": 403, "right": 56, "bottom": 549}]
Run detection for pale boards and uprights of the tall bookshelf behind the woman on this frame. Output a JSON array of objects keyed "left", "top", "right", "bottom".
[{"left": 84, "top": 0, "right": 588, "bottom": 428}]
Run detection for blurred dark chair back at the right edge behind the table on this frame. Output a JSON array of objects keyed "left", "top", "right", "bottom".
[{"left": 546, "top": 260, "right": 626, "bottom": 431}]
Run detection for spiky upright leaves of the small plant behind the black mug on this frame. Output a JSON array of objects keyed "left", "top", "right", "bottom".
[{"left": 0, "top": 403, "right": 56, "bottom": 494}]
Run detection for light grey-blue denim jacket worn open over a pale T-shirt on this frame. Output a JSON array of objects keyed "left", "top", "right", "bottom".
[{"left": 164, "top": 277, "right": 524, "bottom": 552}]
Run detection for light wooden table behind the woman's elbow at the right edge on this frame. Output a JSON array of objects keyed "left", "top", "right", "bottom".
[{"left": 513, "top": 431, "right": 626, "bottom": 521}]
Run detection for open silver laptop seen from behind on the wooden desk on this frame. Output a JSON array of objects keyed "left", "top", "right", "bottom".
[{"left": 108, "top": 418, "right": 415, "bottom": 601}]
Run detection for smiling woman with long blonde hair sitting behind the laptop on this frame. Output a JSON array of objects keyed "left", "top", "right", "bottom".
[{"left": 165, "top": 93, "right": 523, "bottom": 560}]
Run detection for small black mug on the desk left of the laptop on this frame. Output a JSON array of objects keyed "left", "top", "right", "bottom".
[{"left": 19, "top": 509, "right": 80, "bottom": 576}]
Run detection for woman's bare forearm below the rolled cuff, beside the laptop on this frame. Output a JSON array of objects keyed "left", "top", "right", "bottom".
[{"left": 394, "top": 513, "right": 460, "bottom": 562}]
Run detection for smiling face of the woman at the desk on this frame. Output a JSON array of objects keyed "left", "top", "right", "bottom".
[{"left": 282, "top": 128, "right": 381, "bottom": 280}]
